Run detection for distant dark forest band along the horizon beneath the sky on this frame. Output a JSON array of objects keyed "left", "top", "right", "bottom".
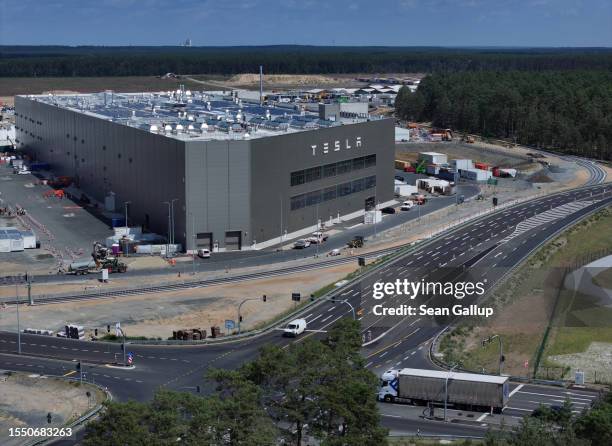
[{"left": 0, "top": 45, "right": 612, "bottom": 77}]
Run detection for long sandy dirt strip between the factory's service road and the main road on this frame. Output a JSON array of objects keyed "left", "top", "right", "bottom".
[{"left": 0, "top": 264, "right": 355, "bottom": 338}]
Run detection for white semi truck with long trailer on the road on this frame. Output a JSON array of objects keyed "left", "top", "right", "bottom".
[{"left": 378, "top": 369, "right": 510, "bottom": 412}]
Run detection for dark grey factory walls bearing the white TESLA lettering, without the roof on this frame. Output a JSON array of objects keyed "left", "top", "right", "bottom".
[{"left": 15, "top": 96, "right": 394, "bottom": 251}]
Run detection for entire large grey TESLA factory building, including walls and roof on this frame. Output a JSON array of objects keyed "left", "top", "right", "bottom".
[{"left": 15, "top": 90, "right": 394, "bottom": 251}]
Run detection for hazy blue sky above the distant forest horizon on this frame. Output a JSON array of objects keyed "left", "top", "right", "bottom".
[{"left": 0, "top": 0, "right": 612, "bottom": 47}]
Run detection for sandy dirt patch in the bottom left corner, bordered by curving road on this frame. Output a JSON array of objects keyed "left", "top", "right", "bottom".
[{"left": 0, "top": 373, "right": 105, "bottom": 446}]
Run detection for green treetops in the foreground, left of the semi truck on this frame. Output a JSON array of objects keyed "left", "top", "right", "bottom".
[{"left": 84, "top": 318, "right": 387, "bottom": 446}]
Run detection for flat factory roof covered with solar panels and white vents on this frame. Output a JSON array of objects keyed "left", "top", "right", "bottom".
[{"left": 24, "top": 89, "right": 379, "bottom": 140}]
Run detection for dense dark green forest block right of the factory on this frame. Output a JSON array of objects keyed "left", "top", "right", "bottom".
[{"left": 395, "top": 70, "right": 612, "bottom": 160}]
